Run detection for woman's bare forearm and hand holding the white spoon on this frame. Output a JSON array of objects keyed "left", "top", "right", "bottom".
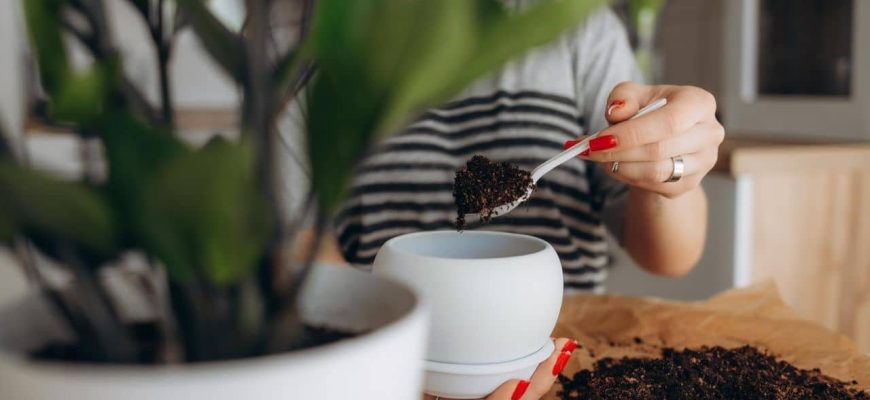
[{"left": 583, "top": 82, "right": 724, "bottom": 276}]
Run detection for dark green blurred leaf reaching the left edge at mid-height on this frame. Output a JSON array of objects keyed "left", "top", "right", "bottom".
[{"left": 0, "top": 162, "right": 117, "bottom": 257}]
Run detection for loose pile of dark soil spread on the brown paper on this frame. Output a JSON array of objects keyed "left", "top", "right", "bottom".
[{"left": 559, "top": 346, "right": 870, "bottom": 400}]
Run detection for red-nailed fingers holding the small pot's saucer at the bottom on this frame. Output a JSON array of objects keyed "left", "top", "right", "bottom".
[{"left": 423, "top": 338, "right": 577, "bottom": 400}]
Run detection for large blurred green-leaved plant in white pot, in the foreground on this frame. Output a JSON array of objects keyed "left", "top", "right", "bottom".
[{"left": 0, "top": 0, "right": 600, "bottom": 399}]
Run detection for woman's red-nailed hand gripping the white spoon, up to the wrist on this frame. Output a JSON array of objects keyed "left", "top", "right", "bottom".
[{"left": 566, "top": 82, "right": 725, "bottom": 198}]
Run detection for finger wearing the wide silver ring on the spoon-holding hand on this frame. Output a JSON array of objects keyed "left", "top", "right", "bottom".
[{"left": 605, "top": 148, "right": 716, "bottom": 186}]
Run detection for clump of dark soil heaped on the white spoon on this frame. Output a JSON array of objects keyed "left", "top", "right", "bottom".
[{"left": 453, "top": 155, "right": 534, "bottom": 231}]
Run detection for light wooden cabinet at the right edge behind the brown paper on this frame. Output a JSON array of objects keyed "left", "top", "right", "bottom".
[{"left": 711, "top": 139, "right": 870, "bottom": 352}]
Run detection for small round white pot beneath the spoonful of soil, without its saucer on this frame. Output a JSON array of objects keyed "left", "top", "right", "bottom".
[{"left": 373, "top": 231, "right": 562, "bottom": 364}]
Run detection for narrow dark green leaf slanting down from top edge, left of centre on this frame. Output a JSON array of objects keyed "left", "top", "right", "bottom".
[{"left": 178, "top": 0, "right": 247, "bottom": 82}]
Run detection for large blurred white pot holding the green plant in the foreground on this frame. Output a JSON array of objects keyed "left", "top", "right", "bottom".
[{"left": 0, "top": 266, "right": 426, "bottom": 400}]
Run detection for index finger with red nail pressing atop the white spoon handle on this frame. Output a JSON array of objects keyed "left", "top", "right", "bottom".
[{"left": 597, "top": 86, "right": 716, "bottom": 150}]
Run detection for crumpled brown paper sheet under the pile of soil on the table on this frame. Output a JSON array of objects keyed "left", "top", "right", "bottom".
[{"left": 548, "top": 282, "right": 870, "bottom": 399}]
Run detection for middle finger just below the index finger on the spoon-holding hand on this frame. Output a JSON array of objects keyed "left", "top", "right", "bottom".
[{"left": 583, "top": 121, "right": 724, "bottom": 162}]
